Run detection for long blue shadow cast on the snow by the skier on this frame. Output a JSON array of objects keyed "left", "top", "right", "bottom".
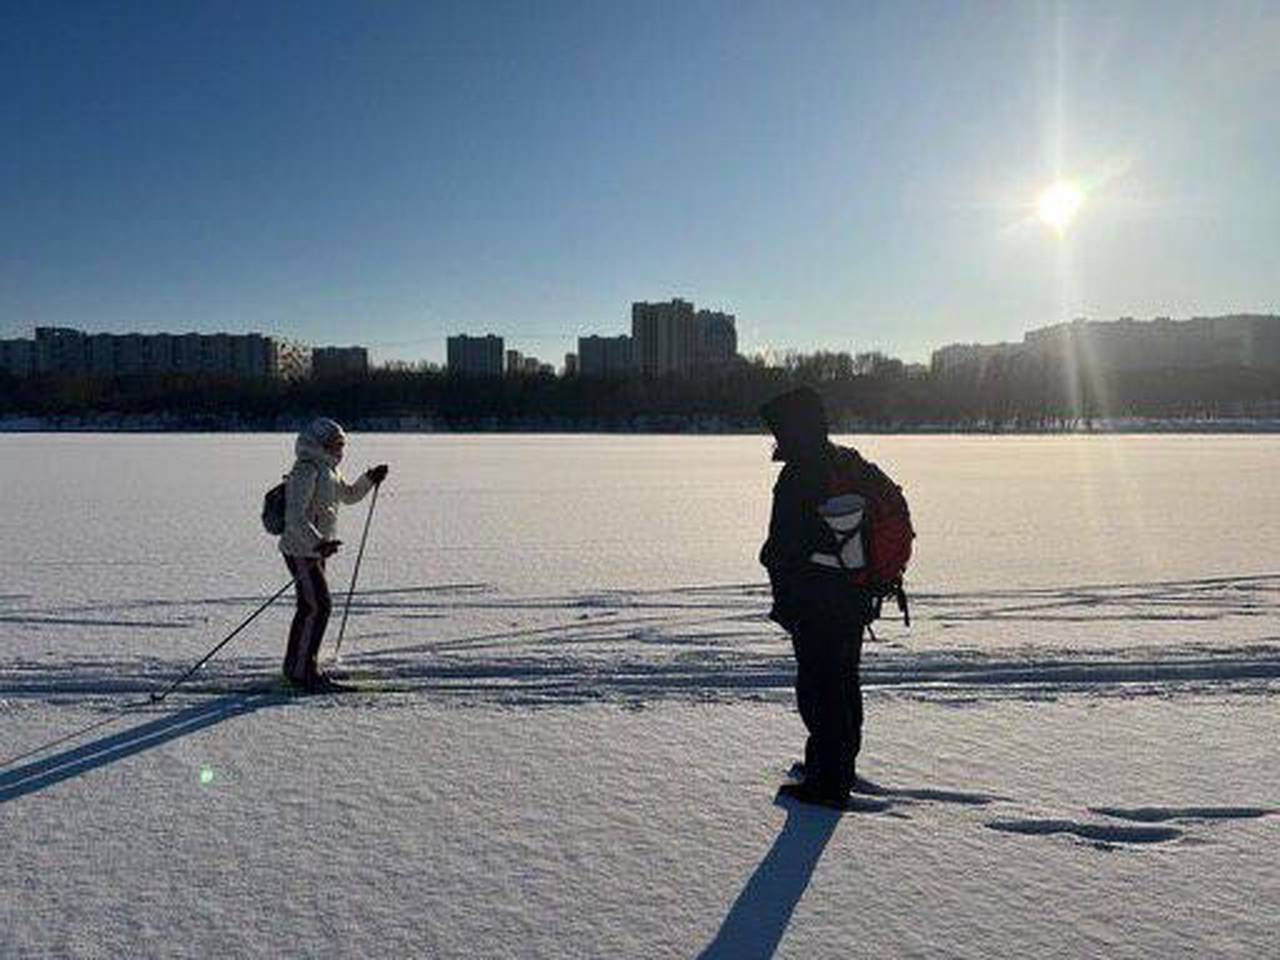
[{"left": 0, "top": 694, "right": 287, "bottom": 804}]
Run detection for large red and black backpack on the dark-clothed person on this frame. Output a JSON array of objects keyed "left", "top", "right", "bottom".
[{"left": 809, "top": 447, "right": 915, "bottom": 626}]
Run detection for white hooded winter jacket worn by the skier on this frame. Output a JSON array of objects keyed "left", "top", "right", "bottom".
[{"left": 280, "top": 434, "right": 374, "bottom": 557}]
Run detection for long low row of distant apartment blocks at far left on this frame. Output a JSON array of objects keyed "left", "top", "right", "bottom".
[{"left": 0, "top": 326, "right": 369, "bottom": 379}]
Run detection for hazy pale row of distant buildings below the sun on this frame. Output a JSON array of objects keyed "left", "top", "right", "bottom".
[{"left": 931, "top": 314, "right": 1280, "bottom": 374}]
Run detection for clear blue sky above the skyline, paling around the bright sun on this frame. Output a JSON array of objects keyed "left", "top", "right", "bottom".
[{"left": 0, "top": 0, "right": 1280, "bottom": 362}]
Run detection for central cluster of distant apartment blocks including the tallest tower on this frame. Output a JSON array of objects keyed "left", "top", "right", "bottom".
[{"left": 447, "top": 298, "right": 737, "bottom": 378}]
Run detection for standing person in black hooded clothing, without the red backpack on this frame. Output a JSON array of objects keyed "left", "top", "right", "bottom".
[{"left": 760, "top": 387, "right": 869, "bottom": 809}]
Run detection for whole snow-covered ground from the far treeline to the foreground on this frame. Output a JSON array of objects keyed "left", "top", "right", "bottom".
[{"left": 0, "top": 435, "right": 1280, "bottom": 957}]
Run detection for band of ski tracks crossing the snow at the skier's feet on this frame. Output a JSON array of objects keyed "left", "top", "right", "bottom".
[{"left": 0, "top": 575, "right": 1280, "bottom": 704}]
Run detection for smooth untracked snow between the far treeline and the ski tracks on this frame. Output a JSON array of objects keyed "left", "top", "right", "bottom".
[{"left": 0, "top": 434, "right": 1280, "bottom": 595}]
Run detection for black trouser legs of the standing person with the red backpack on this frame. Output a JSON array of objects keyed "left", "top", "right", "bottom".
[{"left": 791, "top": 617, "right": 863, "bottom": 795}]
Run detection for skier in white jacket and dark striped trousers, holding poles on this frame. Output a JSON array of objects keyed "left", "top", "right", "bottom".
[{"left": 280, "top": 417, "right": 388, "bottom": 691}]
